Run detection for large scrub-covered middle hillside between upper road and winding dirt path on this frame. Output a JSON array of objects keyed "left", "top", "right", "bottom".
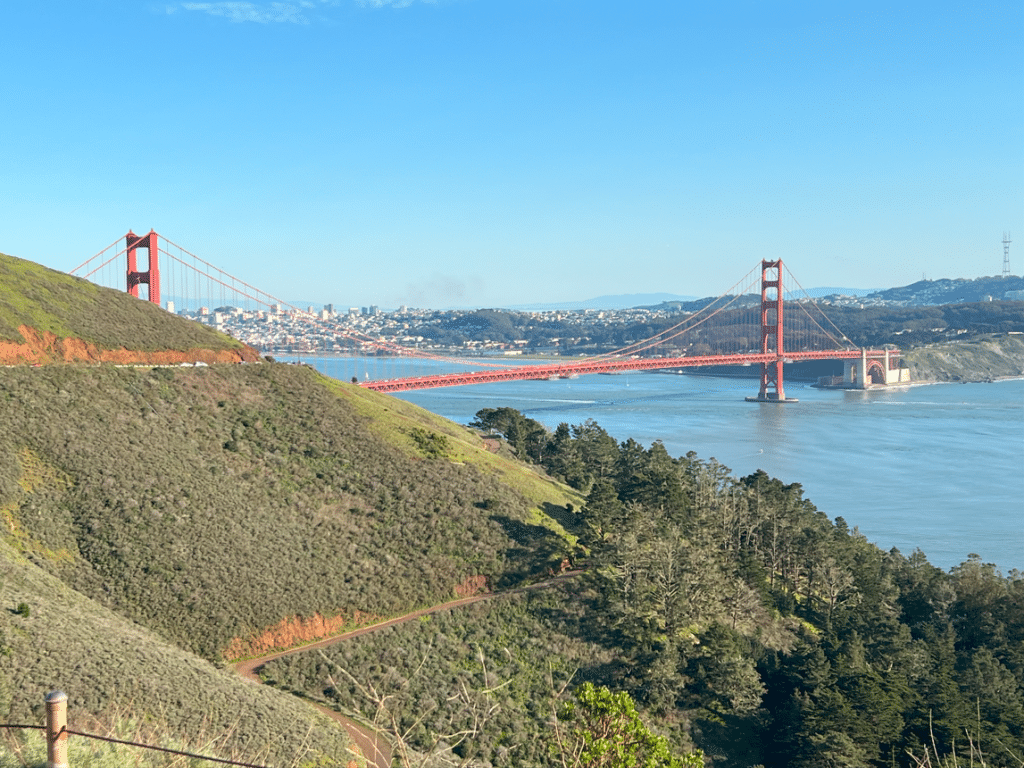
[{"left": 0, "top": 364, "right": 572, "bottom": 659}]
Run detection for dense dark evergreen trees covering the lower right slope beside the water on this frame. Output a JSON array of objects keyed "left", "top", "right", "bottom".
[{"left": 474, "top": 409, "right": 1024, "bottom": 766}]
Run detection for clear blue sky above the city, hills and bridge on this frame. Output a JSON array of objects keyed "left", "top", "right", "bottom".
[{"left": 0, "top": 0, "right": 1024, "bottom": 306}]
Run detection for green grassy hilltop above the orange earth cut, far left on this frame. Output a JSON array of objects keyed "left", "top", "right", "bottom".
[{"left": 0, "top": 253, "right": 244, "bottom": 351}]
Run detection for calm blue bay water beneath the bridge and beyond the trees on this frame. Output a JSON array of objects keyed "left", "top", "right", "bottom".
[{"left": 284, "top": 358, "right": 1024, "bottom": 572}]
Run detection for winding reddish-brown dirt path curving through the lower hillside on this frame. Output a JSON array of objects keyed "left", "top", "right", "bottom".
[{"left": 232, "top": 570, "right": 582, "bottom": 768}]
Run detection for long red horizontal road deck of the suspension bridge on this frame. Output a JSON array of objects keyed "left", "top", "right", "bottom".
[{"left": 359, "top": 349, "right": 899, "bottom": 392}]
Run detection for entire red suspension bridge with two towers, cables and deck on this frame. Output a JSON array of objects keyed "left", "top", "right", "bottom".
[{"left": 71, "top": 230, "right": 903, "bottom": 402}]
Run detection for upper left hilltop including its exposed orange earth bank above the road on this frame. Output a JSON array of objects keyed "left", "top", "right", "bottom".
[{"left": 0, "top": 249, "right": 259, "bottom": 365}]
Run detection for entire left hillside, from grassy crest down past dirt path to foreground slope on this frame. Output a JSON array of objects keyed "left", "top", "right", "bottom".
[{"left": 0, "top": 249, "right": 580, "bottom": 765}]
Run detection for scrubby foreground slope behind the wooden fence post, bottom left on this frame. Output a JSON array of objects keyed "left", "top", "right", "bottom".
[{"left": 0, "top": 544, "right": 356, "bottom": 765}]
